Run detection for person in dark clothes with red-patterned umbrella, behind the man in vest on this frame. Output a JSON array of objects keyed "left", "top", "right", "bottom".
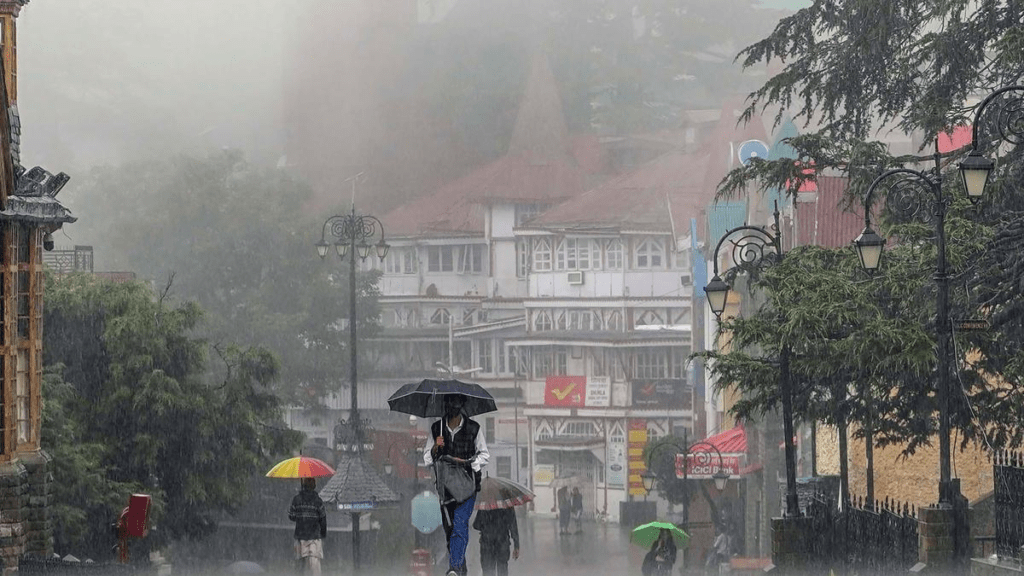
[{"left": 473, "top": 477, "right": 534, "bottom": 576}]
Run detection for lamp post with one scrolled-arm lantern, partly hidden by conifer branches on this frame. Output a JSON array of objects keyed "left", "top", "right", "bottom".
[{"left": 705, "top": 202, "right": 800, "bottom": 518}]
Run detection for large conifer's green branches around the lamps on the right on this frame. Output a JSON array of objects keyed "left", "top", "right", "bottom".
[{"left": 709, "top": 0, "right": 1024, "bottom": 454}]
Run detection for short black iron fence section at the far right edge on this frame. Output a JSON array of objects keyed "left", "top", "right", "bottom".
[{"left": 992, "top": 452, "right": 1024, "bottom": 560}]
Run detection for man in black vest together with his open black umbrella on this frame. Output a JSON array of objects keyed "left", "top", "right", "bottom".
[{"left": 388, "top": 379, "right": 498, "bottom": 576}]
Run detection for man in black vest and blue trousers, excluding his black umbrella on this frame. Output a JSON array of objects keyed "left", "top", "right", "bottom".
[{"left": 423, "top": 395, "right": 490, "bottom": 576}]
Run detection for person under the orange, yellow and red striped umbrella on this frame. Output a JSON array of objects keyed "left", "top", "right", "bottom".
[{"left": 266, "top": 456, "right": 334, "bottom": 576}]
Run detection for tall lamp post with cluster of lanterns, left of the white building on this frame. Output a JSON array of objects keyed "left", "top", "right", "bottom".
[{"left": 316, "top": 202, "right": 390, "bottom": 572}]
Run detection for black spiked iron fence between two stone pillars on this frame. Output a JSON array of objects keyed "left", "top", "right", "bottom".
[{"left": 807, "top": 497, "right": 918, "bottom": 576}]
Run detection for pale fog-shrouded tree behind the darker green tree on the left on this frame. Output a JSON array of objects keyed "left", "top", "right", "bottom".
[{"left": 65, "top": 151, "right": 379, "bottom": 402}]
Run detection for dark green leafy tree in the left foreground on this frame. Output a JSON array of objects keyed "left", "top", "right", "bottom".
[{"left": 43, "top": 276, "right": 300, "bottom": 551}]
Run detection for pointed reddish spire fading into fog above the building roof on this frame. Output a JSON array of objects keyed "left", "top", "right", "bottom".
[{"left": 509, "top": 53, "right": 569, "bottom": 164}]
